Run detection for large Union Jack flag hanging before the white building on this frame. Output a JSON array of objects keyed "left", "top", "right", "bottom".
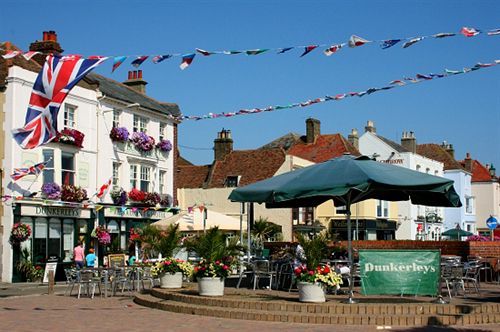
[{"left": 12, "top": 54, "right": 107, "bottom": 149}]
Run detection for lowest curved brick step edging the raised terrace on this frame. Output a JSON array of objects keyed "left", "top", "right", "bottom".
[{"left": 134, "top": 292, "right": 500, "bottom": 326}]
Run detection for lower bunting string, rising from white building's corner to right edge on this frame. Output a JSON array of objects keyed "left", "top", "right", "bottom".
[{"left": 182, "top": 60, "right": 500, "bottom": 120}]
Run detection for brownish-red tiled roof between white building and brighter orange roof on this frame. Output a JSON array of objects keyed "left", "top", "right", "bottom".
[{"left": 207, "top": 148, "right": 285, "bottom": 188}]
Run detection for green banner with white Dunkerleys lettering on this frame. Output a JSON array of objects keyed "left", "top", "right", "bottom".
[{"left": 359, "top": 250, "right": 441, "bottom": 295}]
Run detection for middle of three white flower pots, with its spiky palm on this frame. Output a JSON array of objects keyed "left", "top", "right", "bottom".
[{"left": 185, "top": 227, "right": 244, "bottom": 296}]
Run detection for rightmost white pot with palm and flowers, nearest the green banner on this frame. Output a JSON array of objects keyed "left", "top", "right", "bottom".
[{"left": 294, "top": 234, "right": 342, "bottom": 302}]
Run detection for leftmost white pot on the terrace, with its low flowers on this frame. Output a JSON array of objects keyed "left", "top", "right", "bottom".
[{"left": 151, "top": 258, "right": 193, "bottom": 288}]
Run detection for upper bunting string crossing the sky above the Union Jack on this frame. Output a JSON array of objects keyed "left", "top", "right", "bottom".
[{"left": 3, "top": 27, "right": 500, "bottom": 72}]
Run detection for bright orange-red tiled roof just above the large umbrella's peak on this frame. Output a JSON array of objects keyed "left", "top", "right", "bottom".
[{"left": 288, "top": 134, "right": 360, "bottom": 163}]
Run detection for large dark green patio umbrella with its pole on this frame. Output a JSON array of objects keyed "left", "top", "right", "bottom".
[{"left": 229, "top": 155, "right": 462, "bottom": 303}]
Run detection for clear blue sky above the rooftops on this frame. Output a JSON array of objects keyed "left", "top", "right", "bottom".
[{"left": 0, "top": 0, "right": 500, "bottom": 169}]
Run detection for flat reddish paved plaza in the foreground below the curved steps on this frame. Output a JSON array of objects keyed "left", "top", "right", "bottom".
[{"left": 0, "top": 284, "right": 500, "bottom": 332}]
